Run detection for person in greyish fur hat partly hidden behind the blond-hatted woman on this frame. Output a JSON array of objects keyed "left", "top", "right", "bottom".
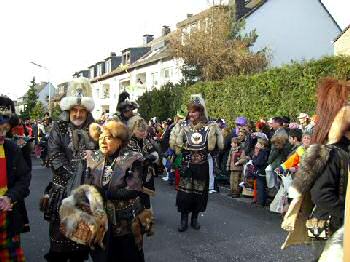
[{"left": 127, "top": 116, "right": 159, "bottom": 209}]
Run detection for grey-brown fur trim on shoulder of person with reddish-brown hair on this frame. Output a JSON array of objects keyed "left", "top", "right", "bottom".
[{"left": 292, "top": 144, "right": 331, "bottom": 194}]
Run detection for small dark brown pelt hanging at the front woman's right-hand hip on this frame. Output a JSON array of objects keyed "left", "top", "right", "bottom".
[{"left": 131, "top": 209, "right": 154, "bottom": 249}]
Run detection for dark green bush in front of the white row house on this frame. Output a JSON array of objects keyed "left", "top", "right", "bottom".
[{"left": 137, "top": 83, "right": 183, "bottom": 120}]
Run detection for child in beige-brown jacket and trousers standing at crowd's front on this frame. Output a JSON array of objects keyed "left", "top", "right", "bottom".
[{"left": 226, "top": 137, "right": 245, "bottom": 197}]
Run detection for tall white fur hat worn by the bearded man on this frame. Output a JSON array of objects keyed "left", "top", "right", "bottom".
[{"left": 60, "top": 77, "right": 95, "bottom": 112}]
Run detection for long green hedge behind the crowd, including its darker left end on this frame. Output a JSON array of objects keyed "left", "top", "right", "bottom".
[{"left": 139, "top": 57, "right": 350, "bottom": 125}]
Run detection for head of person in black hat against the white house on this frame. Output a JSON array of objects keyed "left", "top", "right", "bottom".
[{"left": 114, "top": 91, "right": 139, "bottom": 125}]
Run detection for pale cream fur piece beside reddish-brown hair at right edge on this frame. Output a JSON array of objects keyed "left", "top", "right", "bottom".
[{"left": 328, "top": 105, "right": 350, "bottom": 144}]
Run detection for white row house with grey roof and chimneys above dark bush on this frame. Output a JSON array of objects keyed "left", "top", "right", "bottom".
[{"left": 90, "top": 29, "right": 183, "bottom": 118}]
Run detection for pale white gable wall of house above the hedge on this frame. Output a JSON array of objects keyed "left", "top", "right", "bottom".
[{"left": 246, "top": 0, "right": 340, "bottom": 66}]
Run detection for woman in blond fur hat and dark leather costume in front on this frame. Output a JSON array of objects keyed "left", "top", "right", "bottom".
[{"left": 87, "top": 120, "right": 152, "bottom": 262}]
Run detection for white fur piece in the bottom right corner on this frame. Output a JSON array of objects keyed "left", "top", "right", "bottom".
[{"left": 318, "top": 227, "right": 344, "bottom": 262}]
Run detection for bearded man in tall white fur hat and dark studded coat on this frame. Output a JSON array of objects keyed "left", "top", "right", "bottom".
[{"left": 43, "top": 78, "right": 96, "bottom": 262}]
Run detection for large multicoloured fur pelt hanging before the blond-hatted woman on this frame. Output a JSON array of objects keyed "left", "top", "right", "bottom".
[{"left": 59, "top": 185, "right": 108, "bottom": 247}]
